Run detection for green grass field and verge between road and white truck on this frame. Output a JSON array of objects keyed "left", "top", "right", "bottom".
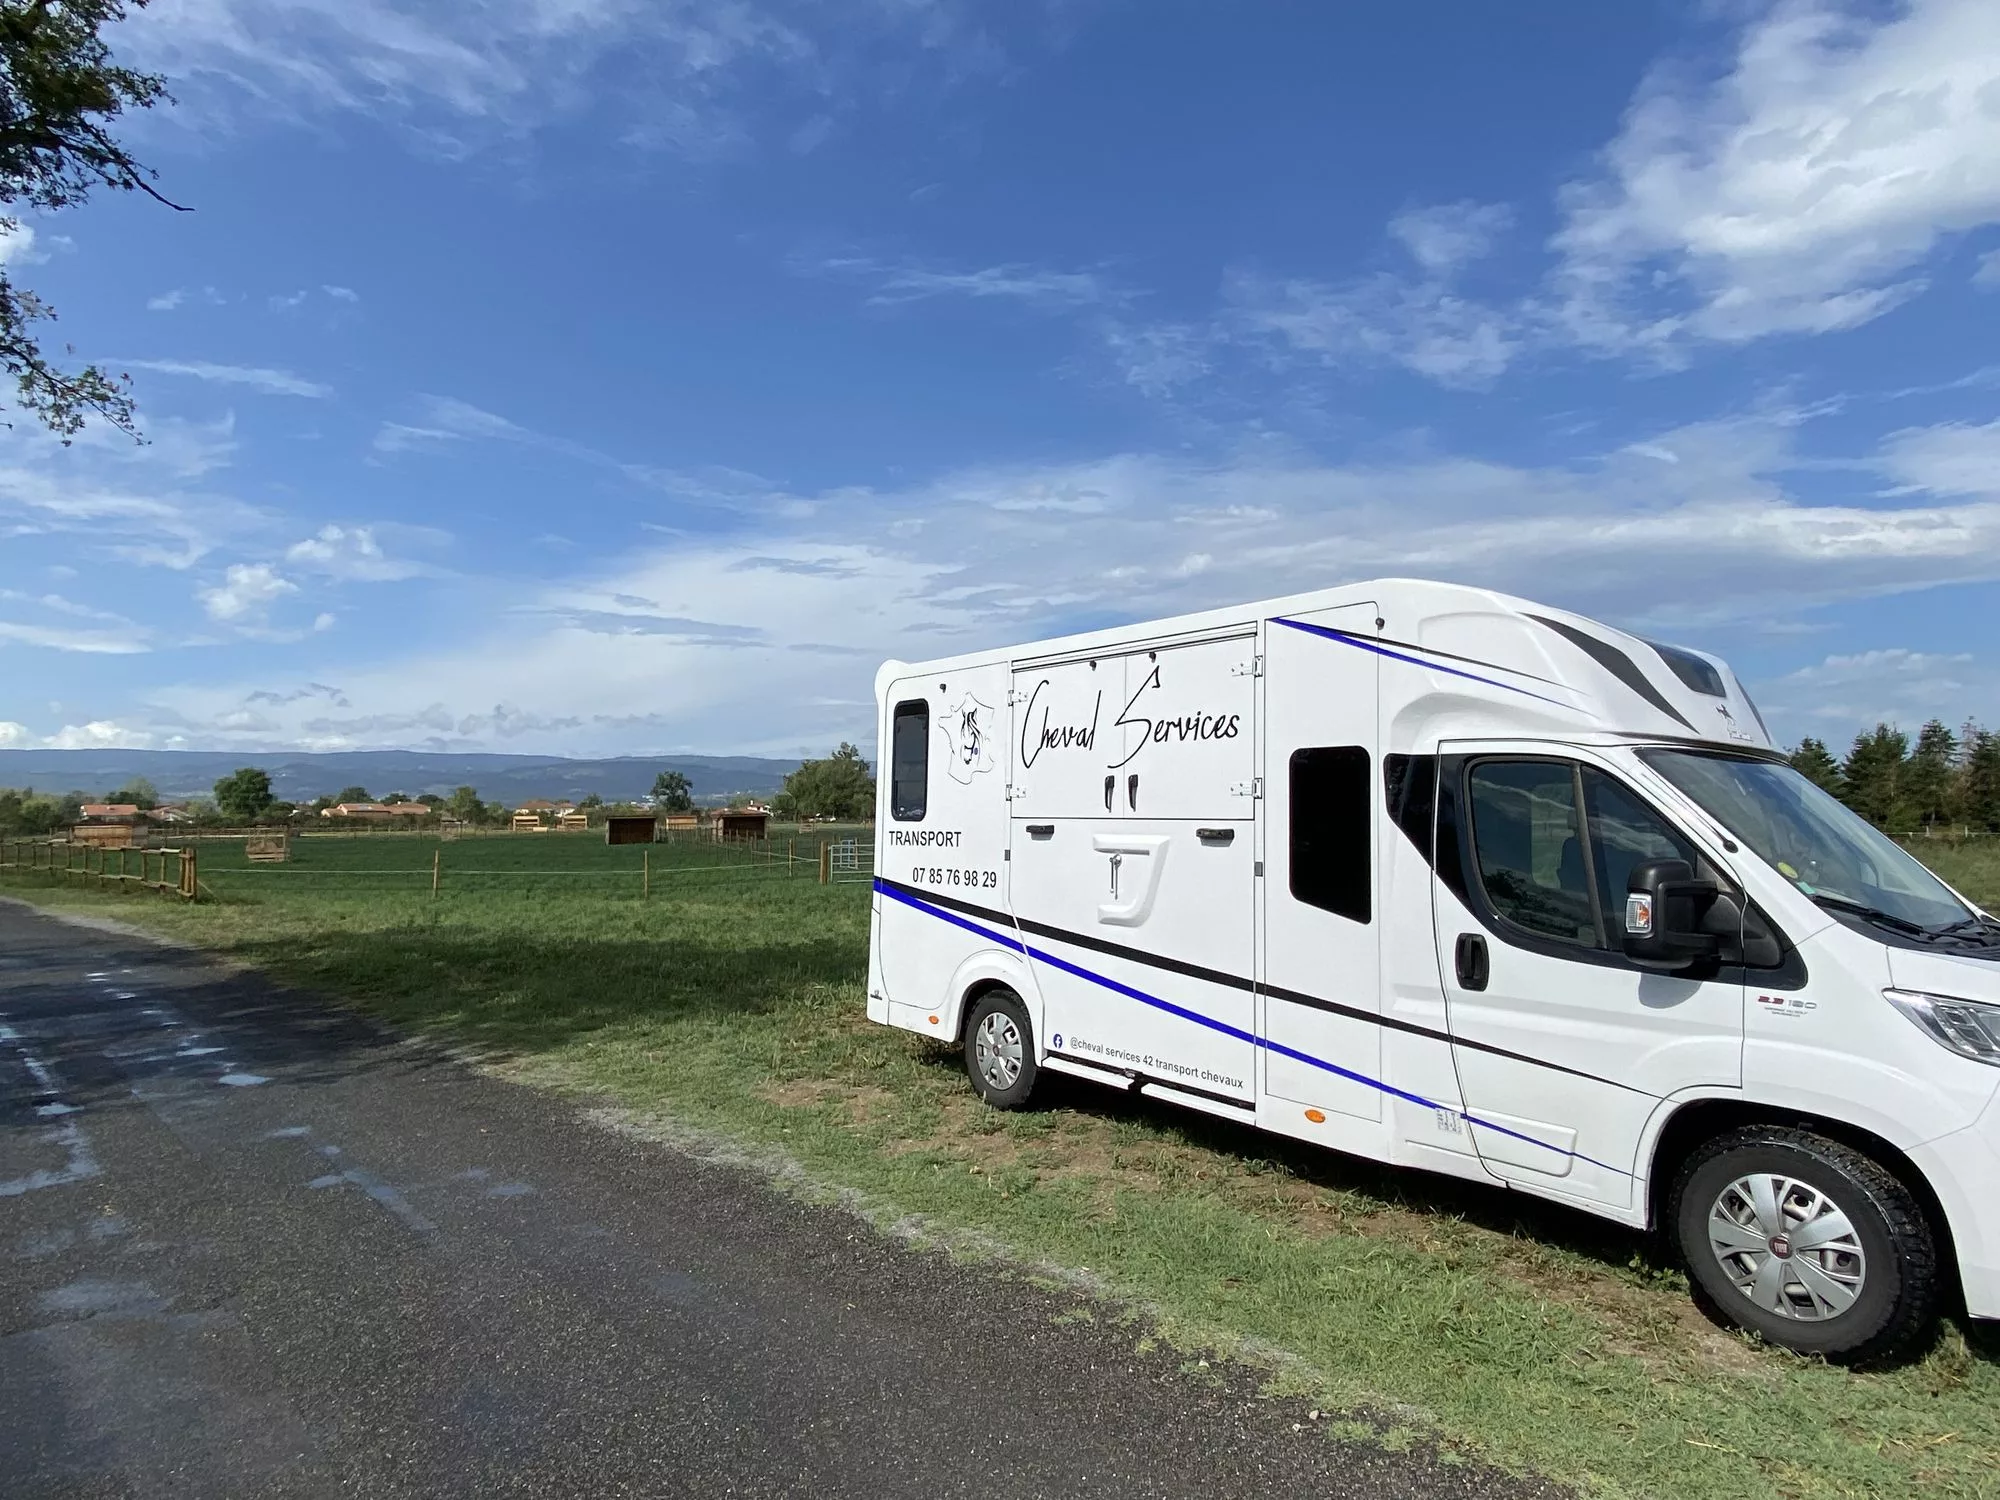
[{"left": 16, "top": 836, "right": 2000, "bottom": 1496}]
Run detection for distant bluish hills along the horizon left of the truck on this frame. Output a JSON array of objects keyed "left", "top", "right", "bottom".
[{"left": 0, "top": 750, "right": 798, "bottom": 806}]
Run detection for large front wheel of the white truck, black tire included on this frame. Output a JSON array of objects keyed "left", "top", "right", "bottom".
[{"left": 1670, "top": 1126, "right": 1938, "bottom": 1364}]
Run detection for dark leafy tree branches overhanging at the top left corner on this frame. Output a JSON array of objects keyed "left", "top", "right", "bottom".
[{"left": 0, "top": 0, "right": 180, "bottom": 442}]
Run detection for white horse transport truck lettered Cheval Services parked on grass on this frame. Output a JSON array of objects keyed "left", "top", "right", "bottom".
[{"left": 868, "top": 580, "right": 2000, "bottom": 1360}]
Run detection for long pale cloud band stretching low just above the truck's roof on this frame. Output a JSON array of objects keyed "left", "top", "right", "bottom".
[{"left": 129, "top": 420, "right": 2000, "bottom": 754}]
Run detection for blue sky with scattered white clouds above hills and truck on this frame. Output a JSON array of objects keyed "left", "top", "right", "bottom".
[{"left": 0, "top": 0, "right": 2000, "bottom": 754}]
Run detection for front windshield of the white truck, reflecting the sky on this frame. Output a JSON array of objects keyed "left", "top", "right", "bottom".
[{"left": 1638, "top": 750, "right": 1970, "bottom": 930}]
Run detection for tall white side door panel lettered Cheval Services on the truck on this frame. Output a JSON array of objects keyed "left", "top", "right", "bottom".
[{"left": 1008, "top": 628, "right": 1258, "bottom": 1110}]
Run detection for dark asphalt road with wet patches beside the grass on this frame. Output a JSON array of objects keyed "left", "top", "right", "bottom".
[{"left": 0, "top": 902, "right": 1546, "bottom": 1500}]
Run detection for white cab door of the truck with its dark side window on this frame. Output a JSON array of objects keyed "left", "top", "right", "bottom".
[{"left": 1434, "top": 744, "right": 1744, "bottom": 1208}]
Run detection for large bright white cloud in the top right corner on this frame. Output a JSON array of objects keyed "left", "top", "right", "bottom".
[{"left": 1552, "top": 0, "right": 2000, "bottom": 350}]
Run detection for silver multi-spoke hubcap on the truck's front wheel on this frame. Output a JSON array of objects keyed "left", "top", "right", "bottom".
[{"left": 1708, "top": 1172, "right": 1868, "bottom": 1322}]
